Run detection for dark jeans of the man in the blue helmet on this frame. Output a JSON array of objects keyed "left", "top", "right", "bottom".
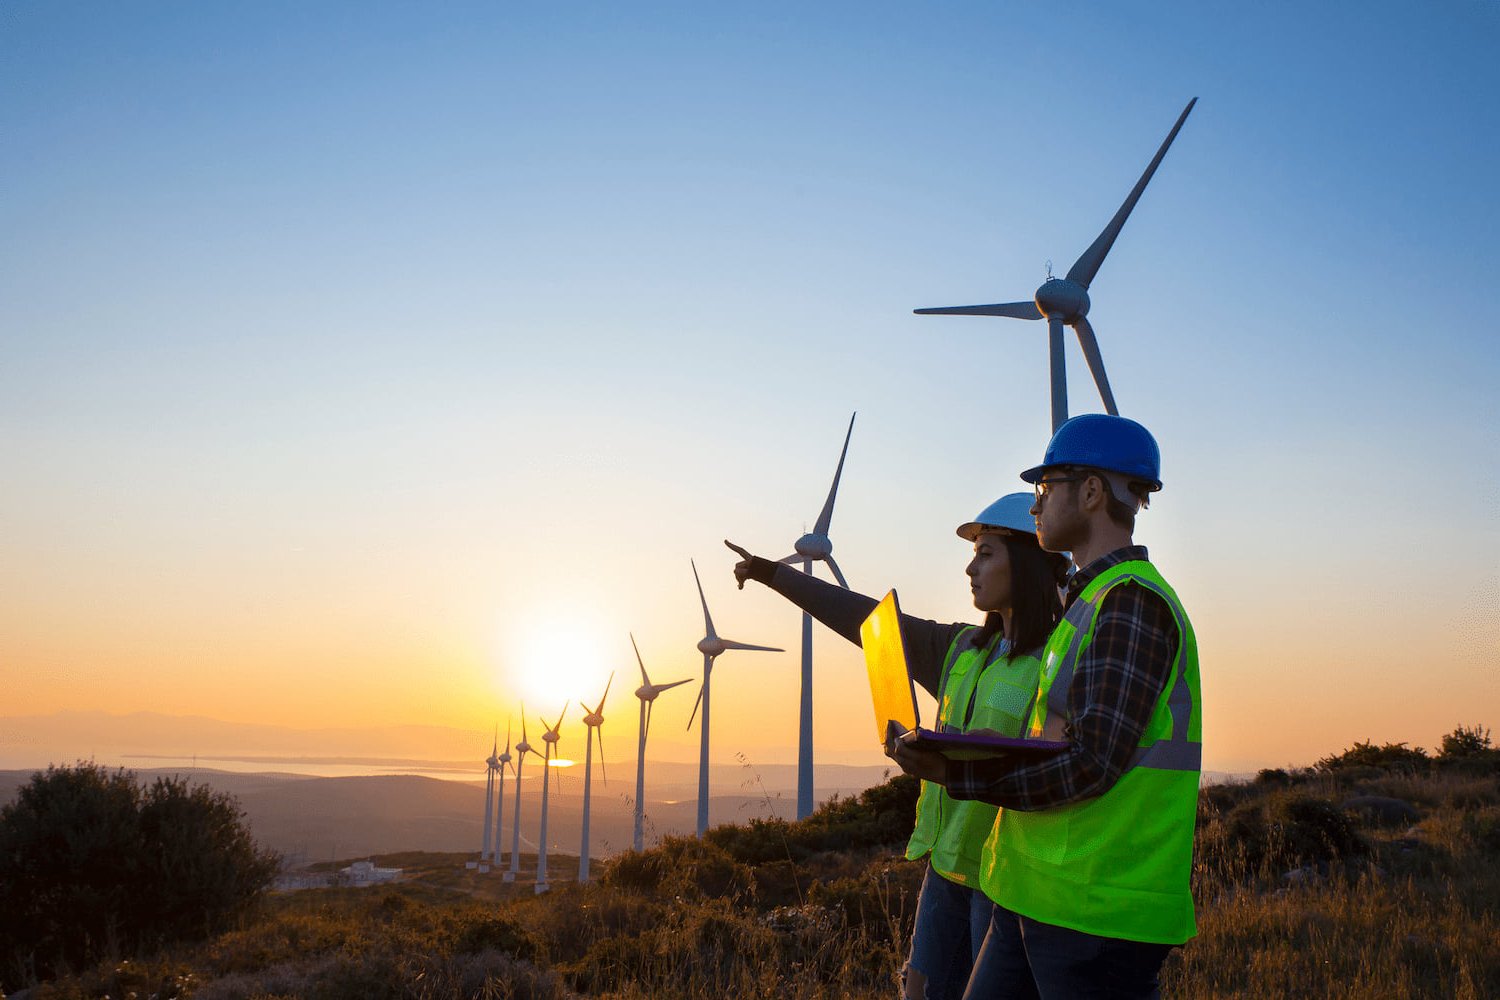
[{"left": 963, "top": 906, "right": 1175, "bottom": 1000}]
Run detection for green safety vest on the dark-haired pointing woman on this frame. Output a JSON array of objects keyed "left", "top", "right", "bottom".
[{"left": 906, "top": 625, "right": 1041, "bottom": 886}]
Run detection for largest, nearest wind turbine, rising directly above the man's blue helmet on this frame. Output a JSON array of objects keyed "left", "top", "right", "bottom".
[{"left": 914, "top": 97, "right": 1199, "bottom": 433}]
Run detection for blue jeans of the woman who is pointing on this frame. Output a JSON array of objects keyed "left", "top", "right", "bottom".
[{"left": 902, "top": 865, "right": 995, "bottom": 1000}]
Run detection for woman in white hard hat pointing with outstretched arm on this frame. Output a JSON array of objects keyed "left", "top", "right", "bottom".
[{"left": 725, "top": 493, "right": 1068, "bottom": 1000}]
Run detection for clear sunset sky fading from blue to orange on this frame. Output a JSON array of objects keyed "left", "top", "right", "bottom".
[{"left": 0, "top": 0, "right": 1500, "bottom": 771}]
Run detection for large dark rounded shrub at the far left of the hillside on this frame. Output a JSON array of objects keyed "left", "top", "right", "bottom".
[{"left": 0, "top": 763, "right": 278, "bottom": 984}]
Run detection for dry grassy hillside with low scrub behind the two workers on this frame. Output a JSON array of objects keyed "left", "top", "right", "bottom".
[{"left": 5, "top": 731, "right": 1500, "bottom": 1000}]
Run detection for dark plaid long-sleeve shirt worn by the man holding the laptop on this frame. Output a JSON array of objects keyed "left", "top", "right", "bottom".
[{"left": 945, "top": 546, "right": 1181, "bottom": 811}]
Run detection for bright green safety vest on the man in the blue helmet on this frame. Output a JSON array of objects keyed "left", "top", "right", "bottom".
[{"left": 981, "top": 559, "right": 1203, "bottom": 945}]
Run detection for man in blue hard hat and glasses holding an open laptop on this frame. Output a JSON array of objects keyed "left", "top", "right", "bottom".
[{"left": 891, "top": 414, "right": 1203, "bottom": 1000}]
